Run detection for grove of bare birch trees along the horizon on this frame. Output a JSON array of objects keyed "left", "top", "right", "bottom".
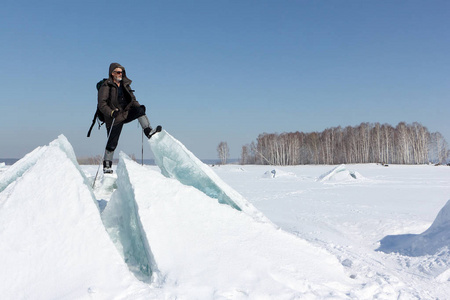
[{"left": 241, "top": 122, "right": 450, "bottom": 165}]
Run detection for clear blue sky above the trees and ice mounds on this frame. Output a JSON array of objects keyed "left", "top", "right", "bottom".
[{"left": 0, "top": 0, "right": 450, "bottom": 158}]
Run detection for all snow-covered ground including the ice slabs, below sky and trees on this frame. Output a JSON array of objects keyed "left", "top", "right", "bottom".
[{"left": 0, "top": 133, "right": 450, "bottom": 299}]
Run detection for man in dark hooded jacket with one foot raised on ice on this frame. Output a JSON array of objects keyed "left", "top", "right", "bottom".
[{"left": 98, "top": 63, "right": 152, "bottom": 173}]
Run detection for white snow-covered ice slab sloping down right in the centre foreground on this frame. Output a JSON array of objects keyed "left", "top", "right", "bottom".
[{"left": 103, "top": 153, "right": 351, "bottom": 299}]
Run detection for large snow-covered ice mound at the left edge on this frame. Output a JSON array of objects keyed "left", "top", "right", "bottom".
[{"left": 0, "top": 136, "right": 150, "bottom": 299}]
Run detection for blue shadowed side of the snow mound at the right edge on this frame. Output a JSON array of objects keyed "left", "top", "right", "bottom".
[{"left": 377, "top": 200, "right": 450, "bottom": 256}]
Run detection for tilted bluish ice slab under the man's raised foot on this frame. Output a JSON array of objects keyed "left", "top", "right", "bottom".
[{"left": 149, "top": 130, "right": 270, "bottom": 222}]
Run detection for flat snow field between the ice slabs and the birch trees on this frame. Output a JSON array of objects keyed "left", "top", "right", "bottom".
[{"left": 213, "top": 164, "right": 450, "bottom": 299}]
